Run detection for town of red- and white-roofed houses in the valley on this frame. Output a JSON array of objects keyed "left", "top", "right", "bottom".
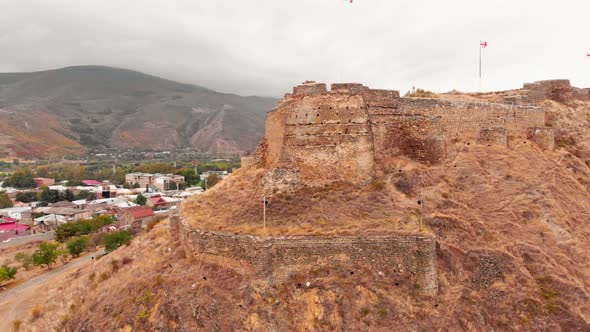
[{"left": 0, "top": 171, "right": 229, "bottom": 244}]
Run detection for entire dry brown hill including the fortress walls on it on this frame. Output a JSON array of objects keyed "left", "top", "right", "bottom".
[{"left": 5, "top": 81, "right": 590, "bottom": 331}]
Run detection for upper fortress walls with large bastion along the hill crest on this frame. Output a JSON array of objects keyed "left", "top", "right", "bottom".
[{"left": 257, "top": 81, "right": 556, "bottom": 183}]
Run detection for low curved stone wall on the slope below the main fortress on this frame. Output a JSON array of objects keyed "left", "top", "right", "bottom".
[{"left": 171, "top": 217, "right": 438, "bottom": 295}]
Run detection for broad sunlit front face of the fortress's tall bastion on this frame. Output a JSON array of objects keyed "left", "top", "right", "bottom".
[{"left": 283, "top": 95, "right": 374, "bottom": 183}]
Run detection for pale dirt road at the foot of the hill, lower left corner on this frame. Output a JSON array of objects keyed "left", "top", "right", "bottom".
[{"left": 0, "top": 252, "right": 104, "bottom": 331}]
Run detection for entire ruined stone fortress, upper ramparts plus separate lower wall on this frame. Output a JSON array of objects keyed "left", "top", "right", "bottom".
[{"left": 178, "top": 80, "right": 590, "bottom": 296}]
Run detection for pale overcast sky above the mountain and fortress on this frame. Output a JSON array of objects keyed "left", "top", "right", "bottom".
[{"left": 0, "top": 0, "right": 590, "bottom": 96}]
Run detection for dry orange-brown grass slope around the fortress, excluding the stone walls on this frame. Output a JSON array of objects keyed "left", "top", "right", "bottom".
[{"left": 12, "top": 102, "right": 590, "bottom": 331}]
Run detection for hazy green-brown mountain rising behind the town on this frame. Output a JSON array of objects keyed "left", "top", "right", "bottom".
[{"left": 0, "top": 66, "right": 277, "bottom": 157}]
